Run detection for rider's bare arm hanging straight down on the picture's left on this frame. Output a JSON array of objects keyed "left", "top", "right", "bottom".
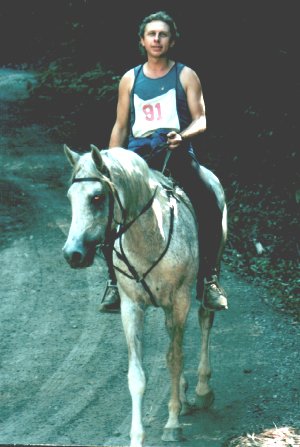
[{"left": 109, "top": 70, "right": 133, "bottom": 148}]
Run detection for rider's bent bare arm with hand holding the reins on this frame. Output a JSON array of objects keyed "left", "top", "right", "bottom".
[{"left": 169, "top": 67, "right": 206, "bottom": 149}]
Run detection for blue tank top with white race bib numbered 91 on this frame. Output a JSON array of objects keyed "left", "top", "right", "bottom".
[{"left": 130, "top": 63, "right": 191, "bottom": 138}]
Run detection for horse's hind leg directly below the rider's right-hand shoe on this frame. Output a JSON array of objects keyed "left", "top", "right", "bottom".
[{"left": 195, "top": 307, "right": 214, "bottom": 408}]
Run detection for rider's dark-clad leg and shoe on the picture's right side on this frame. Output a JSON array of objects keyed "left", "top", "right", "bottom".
[{"left": 169, "top": 153, "right": 227, "bottom": 310}]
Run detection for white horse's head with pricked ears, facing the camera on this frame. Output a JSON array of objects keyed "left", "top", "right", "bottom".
[{"left": 63, "top": 145, "right": 111, "bottom": 268}]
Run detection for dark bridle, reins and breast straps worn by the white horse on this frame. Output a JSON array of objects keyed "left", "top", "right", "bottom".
[{"left": 72, "top": 177, "right": 174, "bottom": 307}]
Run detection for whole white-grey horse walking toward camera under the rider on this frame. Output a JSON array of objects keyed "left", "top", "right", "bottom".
[{"left": 63, "top": 145, "right": 227, "bottom": 447}]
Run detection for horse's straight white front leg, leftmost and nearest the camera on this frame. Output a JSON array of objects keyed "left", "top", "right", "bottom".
[{"left": 121, "top": 296, "right": 146, "bottom": 447}]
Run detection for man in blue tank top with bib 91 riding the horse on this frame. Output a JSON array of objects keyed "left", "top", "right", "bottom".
[{"left": 100, "top": 11, "right": 227, "bottom": 312}]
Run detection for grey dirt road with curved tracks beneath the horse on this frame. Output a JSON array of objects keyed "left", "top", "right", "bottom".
[{"left": 0, "top": 69, "right": 300, "bottom": 447}]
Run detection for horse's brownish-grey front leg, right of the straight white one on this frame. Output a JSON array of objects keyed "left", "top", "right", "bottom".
[{"left": 162, "top": 297, "right": 189, "bottom": 441}]
